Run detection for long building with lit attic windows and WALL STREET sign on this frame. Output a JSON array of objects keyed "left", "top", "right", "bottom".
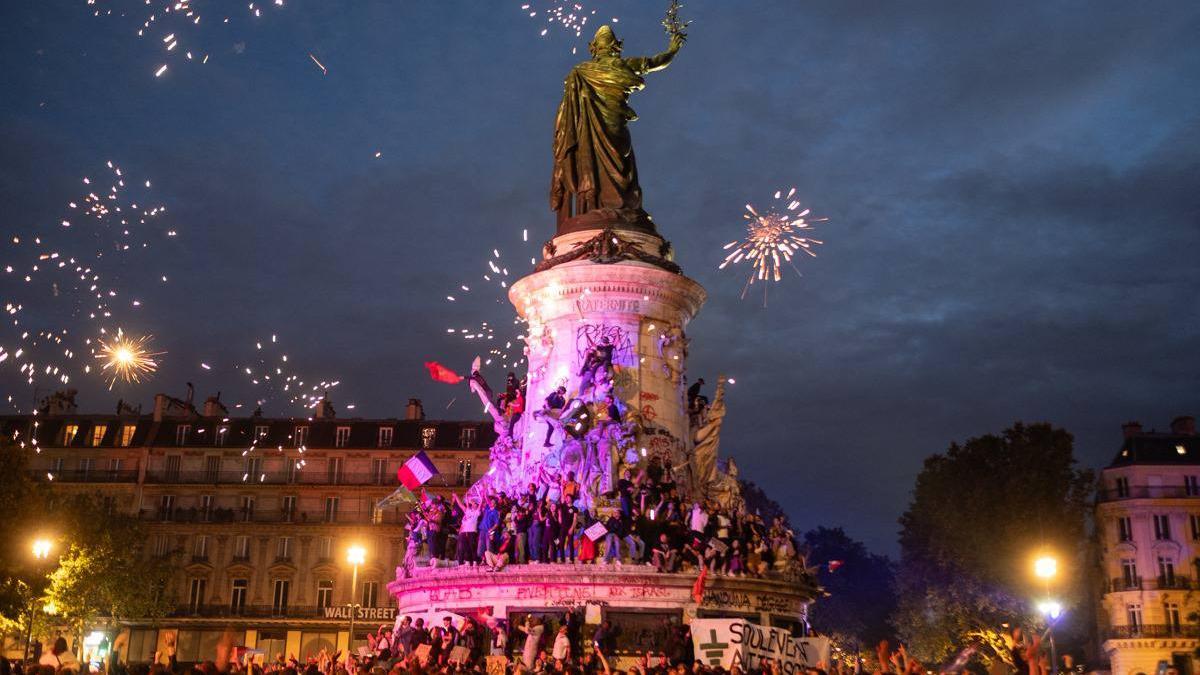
[{"left": 0, "top": 394, "right": 494, "bottom": 662}]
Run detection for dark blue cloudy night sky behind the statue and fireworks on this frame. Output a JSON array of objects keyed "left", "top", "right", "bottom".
[{"left": 0, "top": 0, "right": 1200, "bottom": 552}]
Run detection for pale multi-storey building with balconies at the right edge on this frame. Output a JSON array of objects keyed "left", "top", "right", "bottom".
[{"left": 1094, "top": 417, "right": 1200, "bottom": 675}]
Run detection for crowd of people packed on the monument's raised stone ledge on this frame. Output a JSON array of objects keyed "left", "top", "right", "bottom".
[{"left": 406, "top": 458, "right": 797, "bottom": 577}]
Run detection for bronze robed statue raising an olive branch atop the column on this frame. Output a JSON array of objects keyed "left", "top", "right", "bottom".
[{"left": 550, "top": 25, "right": 685, "bottom": 234}]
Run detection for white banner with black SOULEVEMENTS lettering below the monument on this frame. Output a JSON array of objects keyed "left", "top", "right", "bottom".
[{"left": 691, "top": 619, "right": 829, "bottom": 675}]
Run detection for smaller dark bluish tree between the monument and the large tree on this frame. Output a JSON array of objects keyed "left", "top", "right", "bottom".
[{"left": 804, "top": 527, "right": 896, "bottom": 658}]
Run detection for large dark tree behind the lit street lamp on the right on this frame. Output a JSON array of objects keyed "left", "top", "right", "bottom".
[{"left": 893, "top": 423, "right": 1094, "bottom": 663}]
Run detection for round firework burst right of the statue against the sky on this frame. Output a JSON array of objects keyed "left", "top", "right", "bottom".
[{"left": 718, "top": 187, "right": 829, "bottom": 299}]
